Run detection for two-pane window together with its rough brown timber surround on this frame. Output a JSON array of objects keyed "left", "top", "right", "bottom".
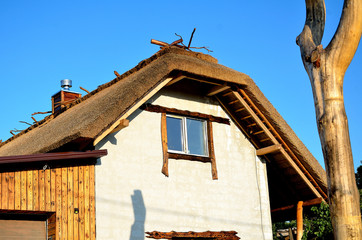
[{"left": 141, "top": 103, "right": 230, "bottom": 180}]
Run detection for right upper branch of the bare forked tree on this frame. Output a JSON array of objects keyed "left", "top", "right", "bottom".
[{"left": 326, "top": 0, "right": 362, "bottom": 75}]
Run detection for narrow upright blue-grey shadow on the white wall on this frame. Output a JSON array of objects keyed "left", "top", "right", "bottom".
[{"left": 129, "top": 189, "right": 146, "bottom": 240}]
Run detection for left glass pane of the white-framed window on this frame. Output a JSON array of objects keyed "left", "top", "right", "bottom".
[{"left": 167, "top": 117, "right": 183, "bottom": 151}]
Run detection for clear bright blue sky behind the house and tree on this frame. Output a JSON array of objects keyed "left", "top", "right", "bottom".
[{"left": 0, "top": 0, "right": 362, "bottom": 171}]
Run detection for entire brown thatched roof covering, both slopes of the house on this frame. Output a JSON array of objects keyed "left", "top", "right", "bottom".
[{"left": 0, "top": 47, "right": 327, "bottom": 218}]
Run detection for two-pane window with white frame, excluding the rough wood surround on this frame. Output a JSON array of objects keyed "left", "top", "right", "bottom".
[{"left": 167, "top": 115, "right": 208, "bottom": 156}]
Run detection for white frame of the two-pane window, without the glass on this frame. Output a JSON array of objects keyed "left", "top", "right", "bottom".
[{"left": 166, "top": 114, "right": 209, "bottom": 157}]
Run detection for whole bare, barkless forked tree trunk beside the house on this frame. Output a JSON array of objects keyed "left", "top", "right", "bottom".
[{"left": 297, "top": 0, "right": 362, "bottom": 240}]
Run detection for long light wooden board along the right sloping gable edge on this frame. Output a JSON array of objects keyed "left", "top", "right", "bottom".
[{"left": 232, "top": 91, "right": 322, "bottom": 197}]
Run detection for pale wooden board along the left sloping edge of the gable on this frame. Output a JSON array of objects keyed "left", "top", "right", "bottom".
[{"left": 93, "top": 78, "right": 174, "bottom": 146}]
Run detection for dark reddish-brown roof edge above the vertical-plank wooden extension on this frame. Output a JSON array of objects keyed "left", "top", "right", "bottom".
[{"left": 0, "top": 149, "right": 108, "bottom": 164}]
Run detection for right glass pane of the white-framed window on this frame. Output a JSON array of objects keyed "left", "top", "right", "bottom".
[{"left": 186, "top": 118, "right": 207, "bottom": 155}]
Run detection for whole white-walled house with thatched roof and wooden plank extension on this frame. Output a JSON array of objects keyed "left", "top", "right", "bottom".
[{"left": 0, "top": 47, "right": 327, "bottom": 240}]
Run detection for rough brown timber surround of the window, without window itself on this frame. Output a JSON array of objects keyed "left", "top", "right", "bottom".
[{"left": 159, "top": 108, "right": 218, "bottom": 180}]
